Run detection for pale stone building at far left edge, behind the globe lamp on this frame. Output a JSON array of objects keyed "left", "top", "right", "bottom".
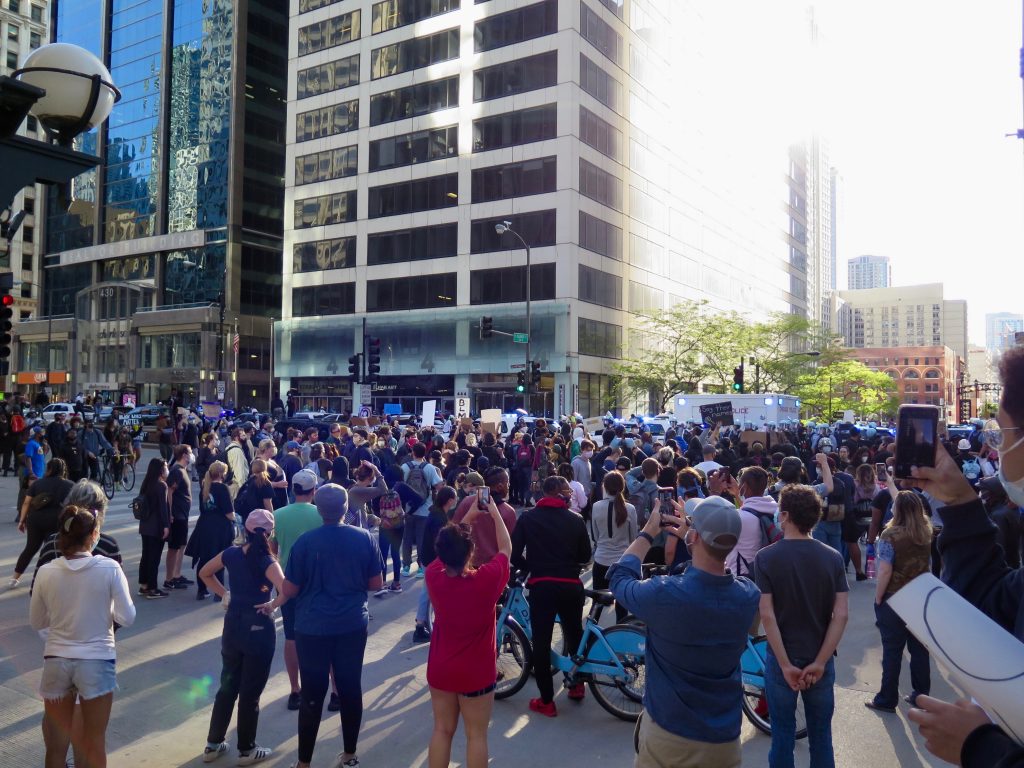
[{"left": 0, "top": 0, "right": 49, "bottom": 325}]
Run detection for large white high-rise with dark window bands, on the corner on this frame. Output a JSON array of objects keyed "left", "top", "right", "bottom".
[{"left": 274, "top": 0, "right": 809, "bottom": 416}]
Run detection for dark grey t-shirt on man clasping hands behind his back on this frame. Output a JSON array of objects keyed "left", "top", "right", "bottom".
[{"left": 754, "top": 539, "right": 850, "bottom": 667}]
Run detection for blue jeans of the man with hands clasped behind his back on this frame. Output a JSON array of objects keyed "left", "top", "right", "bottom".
[{"left": 765, "top": 648, "right": 836, "bottom": 768}]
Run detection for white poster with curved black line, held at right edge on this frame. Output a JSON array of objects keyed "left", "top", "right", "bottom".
[{"left": 889, "top": 573, "right": 1024, "bottom": 744}]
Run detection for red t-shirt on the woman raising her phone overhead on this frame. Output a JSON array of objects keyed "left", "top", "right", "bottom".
[{"left": 424, "top": 553, "right": 509, "bottom": 693}]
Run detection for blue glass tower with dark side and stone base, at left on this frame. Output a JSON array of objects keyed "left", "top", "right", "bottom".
[{"left": 15, "top": 0, "right": 288, "bottom": 406}]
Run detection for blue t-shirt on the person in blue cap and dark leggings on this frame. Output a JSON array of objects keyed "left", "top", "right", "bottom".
[{"left": 285, "top": 525, "right": 382, "bottom": 635}]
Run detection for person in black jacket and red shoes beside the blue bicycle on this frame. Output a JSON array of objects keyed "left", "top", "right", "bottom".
[{"left": 512, "top": 475, "right": 592, "bottom": 718}]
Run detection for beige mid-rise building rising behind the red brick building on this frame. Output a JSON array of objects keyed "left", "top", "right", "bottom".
[{"left": 836, "top": 283, "right": 967, "bottom": 361}]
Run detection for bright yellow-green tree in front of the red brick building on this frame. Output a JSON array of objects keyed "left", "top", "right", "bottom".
[{"left": 793, "top": 359, "right": 899, "bottom": 420}]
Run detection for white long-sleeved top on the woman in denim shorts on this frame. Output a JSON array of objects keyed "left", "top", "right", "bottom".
[{"left": 29, "top": 555, "right": 135, "bottom": 659}]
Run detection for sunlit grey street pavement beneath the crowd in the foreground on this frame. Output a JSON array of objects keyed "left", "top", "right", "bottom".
[{"left": 0, "top": 451, "right": 954, "bottom": 768}]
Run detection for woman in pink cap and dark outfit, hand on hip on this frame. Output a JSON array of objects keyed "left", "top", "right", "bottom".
[{"left": 199, "top": 507, "right": 287, "bottom": 765}]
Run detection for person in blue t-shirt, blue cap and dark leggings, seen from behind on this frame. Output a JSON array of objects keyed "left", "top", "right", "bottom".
[{"left": 275, "top": 483, "right": 384, "bottom": 768}]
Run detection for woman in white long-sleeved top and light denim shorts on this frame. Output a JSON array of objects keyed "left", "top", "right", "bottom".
[{"left": 29, "top": 506, "right": 135, "bottom": 768}]
